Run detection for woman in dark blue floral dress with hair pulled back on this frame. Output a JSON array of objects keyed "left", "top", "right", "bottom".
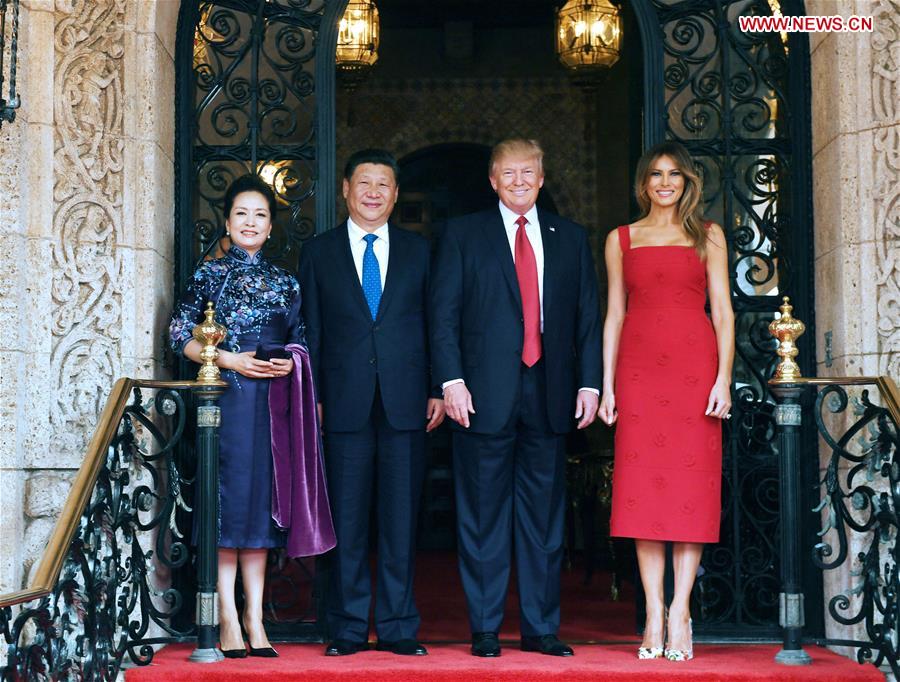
[{"left": 169, "top": 175, "right": 305, "bottom": 658}]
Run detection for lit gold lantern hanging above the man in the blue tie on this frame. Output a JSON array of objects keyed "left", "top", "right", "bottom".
[{"left": 335, "top": 0, "right": 381, "bottom": 90}]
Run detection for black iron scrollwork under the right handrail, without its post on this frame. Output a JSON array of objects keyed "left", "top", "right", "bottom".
[{"left": 812, "top": 385, "right": 900, "bottom": 676}]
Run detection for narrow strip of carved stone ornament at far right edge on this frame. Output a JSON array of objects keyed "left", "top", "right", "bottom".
[{"left": 870, "top": 0, "right": 900, "bottom": 378}]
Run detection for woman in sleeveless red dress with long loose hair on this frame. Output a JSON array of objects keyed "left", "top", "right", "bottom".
[{"left": 599, "top": 142, "right": 734, "bottom": 661}]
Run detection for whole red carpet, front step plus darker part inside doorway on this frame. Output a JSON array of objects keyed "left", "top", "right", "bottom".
[{"left": 126, "top": 552, "right": 884, "bottom": 682}]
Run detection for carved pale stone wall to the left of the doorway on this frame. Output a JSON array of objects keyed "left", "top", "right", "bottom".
[{"left": 0, "top": 0, "right": 179, "bottom": 592}]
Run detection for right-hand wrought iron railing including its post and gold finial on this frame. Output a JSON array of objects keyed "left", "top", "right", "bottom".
[{"left": 769, "top": 300, "right": 900, "bottom": 677}]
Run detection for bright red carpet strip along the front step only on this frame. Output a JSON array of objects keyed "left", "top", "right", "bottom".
[{"left": 125, "top": 644, "right": 884, "bottom": 682}]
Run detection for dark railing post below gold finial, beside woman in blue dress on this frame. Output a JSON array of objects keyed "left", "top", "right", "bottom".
[{"left": 189, "top": 384, "right": 224, "bottom": 663}]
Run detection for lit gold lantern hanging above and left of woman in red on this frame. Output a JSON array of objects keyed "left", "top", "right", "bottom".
[{"left": 556, "top": 0, "right": 622, "bottom": 88}]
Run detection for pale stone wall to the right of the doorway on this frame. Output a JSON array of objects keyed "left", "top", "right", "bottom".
[{"left": 806, "top": 0, "right": 900, "bottom": 653}]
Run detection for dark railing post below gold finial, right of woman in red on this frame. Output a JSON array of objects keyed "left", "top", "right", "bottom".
[{"left": 770, "top": 384, "right": 812, "bottom": 665}]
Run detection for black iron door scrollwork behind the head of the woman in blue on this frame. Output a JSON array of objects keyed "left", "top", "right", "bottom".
[{"left": 189, "top": 0, "right": 330, "bottom": 269}]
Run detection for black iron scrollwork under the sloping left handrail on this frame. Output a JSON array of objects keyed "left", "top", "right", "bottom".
[{"left": 0, "top": 388, "right": 193, "bottom": 681}]
